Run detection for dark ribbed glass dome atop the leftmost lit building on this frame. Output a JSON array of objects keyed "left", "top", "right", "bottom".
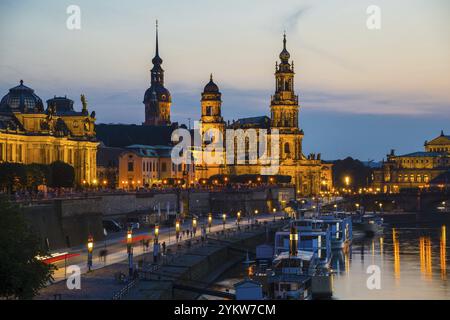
[{"left": 0, "top": 80, "right": 44, "bottom": 112}]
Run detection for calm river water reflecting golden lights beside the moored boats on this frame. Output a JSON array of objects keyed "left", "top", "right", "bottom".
[{"left": 209, "top": 215, "right": 450, "bottom": 300}]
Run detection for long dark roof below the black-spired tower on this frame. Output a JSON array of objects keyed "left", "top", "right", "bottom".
[{"left": 95, "top": 124, "right": 178, "bottom": 148}]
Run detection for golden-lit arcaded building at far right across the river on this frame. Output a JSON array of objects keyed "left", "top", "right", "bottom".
[{"left": 373, "top": 132, "right": 450, "bottom": 193}]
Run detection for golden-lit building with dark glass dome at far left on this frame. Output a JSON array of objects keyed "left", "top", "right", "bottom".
[{"left": 0, "top": 81, "right": 98, "bottom": 184}]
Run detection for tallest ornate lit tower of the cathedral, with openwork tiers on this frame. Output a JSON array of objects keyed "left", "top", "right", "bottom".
[{"left": 270, "top": 34, "right": 303, "bottom": 161}]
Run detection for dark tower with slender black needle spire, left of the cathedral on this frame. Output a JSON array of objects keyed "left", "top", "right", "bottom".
[{"left": 144, "top": 21, "right": 172, "bottom": 126}]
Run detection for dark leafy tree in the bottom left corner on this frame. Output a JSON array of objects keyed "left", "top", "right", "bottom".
[{"left": 0, "top": 199, "right": 54, "bottom": 299}]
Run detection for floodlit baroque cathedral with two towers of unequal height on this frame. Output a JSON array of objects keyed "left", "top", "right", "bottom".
[{"left": 195, "top": 35, "right": 332, "bottom": 196}]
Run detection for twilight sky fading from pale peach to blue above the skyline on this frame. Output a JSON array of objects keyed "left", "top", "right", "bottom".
[{"left": 0, "top": 0, "right": 450, "bottom": 160}]
